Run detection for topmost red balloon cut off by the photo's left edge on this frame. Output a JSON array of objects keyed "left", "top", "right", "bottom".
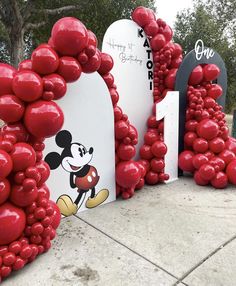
[{"left": 0, "top": 63, "right": 16, "bottom": 96}]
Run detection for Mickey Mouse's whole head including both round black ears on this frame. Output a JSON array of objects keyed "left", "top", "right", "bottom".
[{"left": 45, "top": 130, "right": 93, "bottom": 173}]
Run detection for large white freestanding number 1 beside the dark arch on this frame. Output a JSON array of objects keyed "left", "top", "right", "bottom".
[{"left": 156, "top": 91, "right": 179, "bottom": 183}]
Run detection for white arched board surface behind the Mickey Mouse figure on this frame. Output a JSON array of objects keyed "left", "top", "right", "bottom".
[{"left": 44, "top": 73, "right": 116, "bottom": 212}]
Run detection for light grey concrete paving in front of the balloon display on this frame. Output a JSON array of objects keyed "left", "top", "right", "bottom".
[{"left": 2, "top": 178, "right": 236, "bottom": 286}]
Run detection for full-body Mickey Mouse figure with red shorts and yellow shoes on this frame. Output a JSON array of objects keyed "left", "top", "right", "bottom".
[{"left": 45, "top": 130, "right": 109, "bottom": 216}]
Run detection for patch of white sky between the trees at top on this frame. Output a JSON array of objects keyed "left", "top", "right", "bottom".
[{"left": 156, "top": 0, "right": 193, "bottom": 28}]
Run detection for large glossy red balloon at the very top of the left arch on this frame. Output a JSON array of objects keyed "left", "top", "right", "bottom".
[{"left": 52, "top": 17, "right": 88, "bottom": 56}]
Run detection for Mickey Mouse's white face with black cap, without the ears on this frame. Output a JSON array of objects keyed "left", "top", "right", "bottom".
[{"left": 61, "top": 143, "right": 93, "bottom": 173}]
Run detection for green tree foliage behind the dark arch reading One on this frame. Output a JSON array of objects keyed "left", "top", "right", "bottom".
[{"left": 174, "top": 0, "right": 236, "bottom": 112}]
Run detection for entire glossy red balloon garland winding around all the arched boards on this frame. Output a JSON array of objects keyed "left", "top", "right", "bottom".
[{"left": 0, "top": 7, "right": 236, "bottom": 281}]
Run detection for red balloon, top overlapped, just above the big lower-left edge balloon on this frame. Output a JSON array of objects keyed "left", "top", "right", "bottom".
[{"left": 10, "top": 185, "right": 38, "bottom": 207}]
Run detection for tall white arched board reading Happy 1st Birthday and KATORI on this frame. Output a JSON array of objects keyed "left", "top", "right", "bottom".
[{"left": 102, "top": 20, "right": 153, "bottom": 159}]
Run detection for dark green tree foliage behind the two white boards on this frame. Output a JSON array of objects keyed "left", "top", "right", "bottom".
[{"left": 0, "top": 0, "right": 155, "bottom": 62}]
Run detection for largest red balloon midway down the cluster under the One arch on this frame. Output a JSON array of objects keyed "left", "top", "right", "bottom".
[{"left": 197, "top": 119, "right": 219, "bottom": 140}]
